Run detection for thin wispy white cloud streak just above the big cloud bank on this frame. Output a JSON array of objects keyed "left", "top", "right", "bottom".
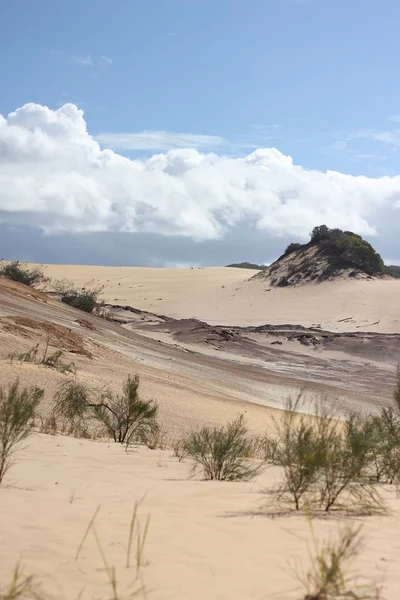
[{"left": 96, "top": 131, "right": 225, "bottom": 150}]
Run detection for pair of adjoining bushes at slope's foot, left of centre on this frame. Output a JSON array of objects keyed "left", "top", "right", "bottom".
[{"left": 53, "top": 375, "right": 159, "bottom": 445}]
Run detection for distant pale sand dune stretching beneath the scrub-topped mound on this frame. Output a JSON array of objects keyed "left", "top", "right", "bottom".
[{"left": 39, "top": 265, "right": 400, "bottom": 333}]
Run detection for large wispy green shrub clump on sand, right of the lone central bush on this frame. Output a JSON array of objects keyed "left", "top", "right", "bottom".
[{"left": 273, "top": 395, "right": 384, "bottom": 512}]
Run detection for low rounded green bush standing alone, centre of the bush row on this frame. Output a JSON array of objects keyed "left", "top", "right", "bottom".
[{"left": 181, "top": 415, "right": 260, "bottom": 481}]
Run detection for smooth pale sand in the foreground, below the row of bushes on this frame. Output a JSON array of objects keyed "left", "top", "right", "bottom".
[{"left": 0, "top": 435, "right": 400, "bottom": 600}]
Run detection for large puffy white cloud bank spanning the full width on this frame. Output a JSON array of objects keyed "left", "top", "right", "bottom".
[{"left": 0, "top": 104, "right": 400, "bottom": 240}]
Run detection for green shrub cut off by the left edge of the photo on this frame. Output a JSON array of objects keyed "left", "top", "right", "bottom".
[{"left": 0, "top": 380, "right": 44, "bottom": 483}]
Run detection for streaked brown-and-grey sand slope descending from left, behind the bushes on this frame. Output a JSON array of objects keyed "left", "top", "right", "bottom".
[{"left": 0, "top": 280, "right": 396, "bottom": 414}]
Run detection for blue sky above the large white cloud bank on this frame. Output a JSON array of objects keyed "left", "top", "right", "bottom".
[{"left": 0, "top": 0, "right": 400, "bottom": 258}]
